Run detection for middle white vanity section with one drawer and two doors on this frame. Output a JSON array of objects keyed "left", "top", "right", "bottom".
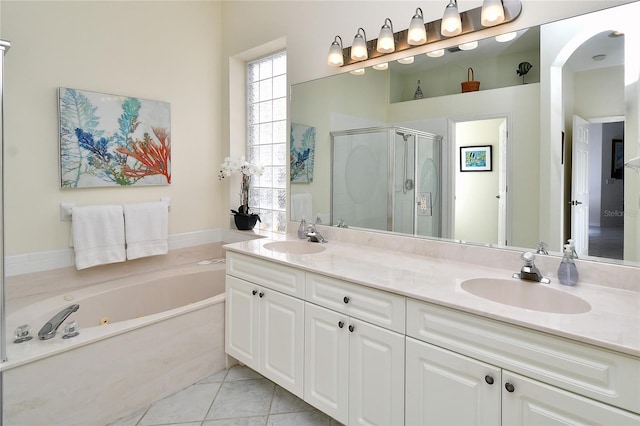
[{"left": 304, "top": 273, "right": 405, "bottom": 425}]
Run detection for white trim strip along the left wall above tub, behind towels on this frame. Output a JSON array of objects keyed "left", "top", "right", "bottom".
[{"left": 4, "top": 228, "right": 229, "bottom": 277}]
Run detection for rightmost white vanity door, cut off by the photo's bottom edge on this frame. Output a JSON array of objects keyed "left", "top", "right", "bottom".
[{"left": 502, "top": 371, "right": 640, "bottom": 426}]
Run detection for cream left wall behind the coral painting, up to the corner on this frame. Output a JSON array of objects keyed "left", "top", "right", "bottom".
[{"left": 1, "top": 1, "right": 224, "bottom": 255}]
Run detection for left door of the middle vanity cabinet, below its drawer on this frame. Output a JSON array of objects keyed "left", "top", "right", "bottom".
[{"left": 304, "top": 303, "right": 349, "bottom": 424}]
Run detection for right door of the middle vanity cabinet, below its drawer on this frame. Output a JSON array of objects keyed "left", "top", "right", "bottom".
[{"left": 349, "top": 318, "right": 404, "bottom": 425}]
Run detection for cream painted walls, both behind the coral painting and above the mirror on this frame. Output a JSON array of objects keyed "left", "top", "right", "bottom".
[{"left": 0, "top": 0, "right": 626, "bottom": 255}]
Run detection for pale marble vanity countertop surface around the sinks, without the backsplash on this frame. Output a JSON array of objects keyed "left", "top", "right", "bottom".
[{"left": 224, "top": 235, "right": 640, "bottom": 356}]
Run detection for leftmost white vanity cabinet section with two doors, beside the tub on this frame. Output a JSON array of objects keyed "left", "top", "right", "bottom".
[{"left": 225, "top": 253, "right": 304, "bottom": 398}]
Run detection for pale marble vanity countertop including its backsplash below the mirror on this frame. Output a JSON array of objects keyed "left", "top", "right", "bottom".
[{"left": 236, "top": 224, "right": 640, "bottom": 356}]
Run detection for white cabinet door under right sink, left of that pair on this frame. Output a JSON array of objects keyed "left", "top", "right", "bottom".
[{"left": 406, "top": 337, "right": 502, "bottom": 426}]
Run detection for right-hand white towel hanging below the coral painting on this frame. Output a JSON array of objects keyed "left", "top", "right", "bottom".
[{"left": 124, "top": 201, "right": 169, "bottom": 260}]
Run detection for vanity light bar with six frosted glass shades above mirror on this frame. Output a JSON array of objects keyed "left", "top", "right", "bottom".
[{"left": 327, "top": 0, "right": 522, "bottom": 68}]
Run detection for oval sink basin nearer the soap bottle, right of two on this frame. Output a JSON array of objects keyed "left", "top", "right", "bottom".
[{"left": 462, "top": 278, "right": 591, "bottom": 314}]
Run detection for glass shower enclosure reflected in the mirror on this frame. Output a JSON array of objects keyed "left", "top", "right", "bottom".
[{"left": 331, "top": 126, "right": 442, "bottom": 237}]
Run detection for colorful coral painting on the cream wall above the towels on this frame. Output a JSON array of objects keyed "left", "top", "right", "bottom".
[{"left": 58, "top": 87, "right": 171, "bottom": 188}]
